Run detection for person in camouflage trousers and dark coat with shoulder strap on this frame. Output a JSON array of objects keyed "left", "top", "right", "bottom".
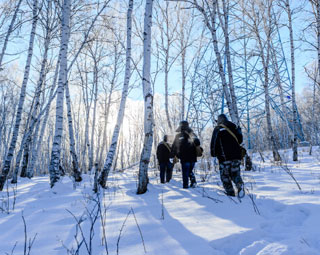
[{"left": 210, "top": 114, "right": 244, "bottom": 197}]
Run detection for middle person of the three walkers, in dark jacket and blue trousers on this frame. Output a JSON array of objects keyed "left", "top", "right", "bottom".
[{"left": 172, "top": 120, "right": 200, "bottom": 189}]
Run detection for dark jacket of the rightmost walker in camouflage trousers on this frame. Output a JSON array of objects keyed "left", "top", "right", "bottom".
[{"left": 210, "top": 121, "right": 243, "bottom": 162}]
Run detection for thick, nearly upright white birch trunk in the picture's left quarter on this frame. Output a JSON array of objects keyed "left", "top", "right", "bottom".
[{"left": 49, "top": 0, "right": 71, "bottom": 187}]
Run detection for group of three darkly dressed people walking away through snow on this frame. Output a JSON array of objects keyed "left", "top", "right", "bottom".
[{"left": 157, "top": 114, "right": 244, "bottom": 197}]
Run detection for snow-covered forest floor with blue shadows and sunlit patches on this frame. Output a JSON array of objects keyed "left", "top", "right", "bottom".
[{"left": 0, "top": 148, "right": 320, "bottom": 255}]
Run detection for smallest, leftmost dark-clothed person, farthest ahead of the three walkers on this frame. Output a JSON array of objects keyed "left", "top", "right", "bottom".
[{"left": 157, "top": 135, "right": 173, "bottom": 183}]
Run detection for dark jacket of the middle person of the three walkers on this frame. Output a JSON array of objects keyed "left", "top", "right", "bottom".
[{"left": 172, "top": 128, "right": 200, "bottom": 163}]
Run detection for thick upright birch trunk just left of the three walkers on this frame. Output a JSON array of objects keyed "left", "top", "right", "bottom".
[{"left": 137, "top": 0, "right": 153, "bottom": 194}]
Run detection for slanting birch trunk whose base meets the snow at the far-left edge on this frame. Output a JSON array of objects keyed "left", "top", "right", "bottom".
[{"left": 0, "top": 0, "right": 38, "bottom": 191}]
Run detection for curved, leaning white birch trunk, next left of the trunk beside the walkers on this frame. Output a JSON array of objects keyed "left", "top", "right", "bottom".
[{"left": 99, "top": 0, "right": 133, "bottom": 188}]
